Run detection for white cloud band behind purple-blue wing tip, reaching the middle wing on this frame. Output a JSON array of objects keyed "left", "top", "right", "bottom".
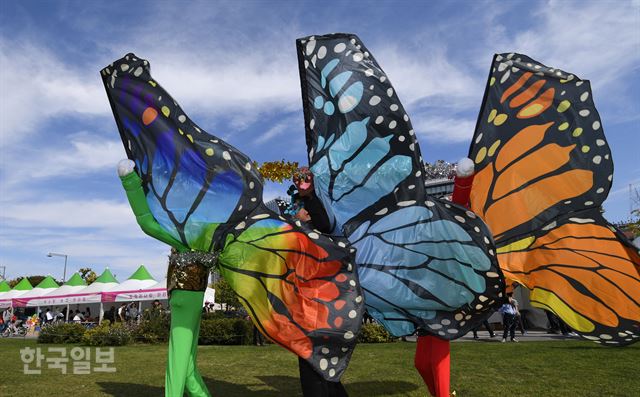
[{"left": 0, "top": 32, "right": 300, "bottom": 151}]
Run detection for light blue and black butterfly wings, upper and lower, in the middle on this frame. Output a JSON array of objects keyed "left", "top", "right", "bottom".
[{"left": 297, "top": 34, "right": 504, "bottom": 339}]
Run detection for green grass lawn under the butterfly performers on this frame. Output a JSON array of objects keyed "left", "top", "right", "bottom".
[{"left": 0, "top": 339, "right": 640, "bottom": 397}]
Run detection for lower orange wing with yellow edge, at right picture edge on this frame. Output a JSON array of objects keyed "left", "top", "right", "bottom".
[{"left": 498, "top": 210, "right": 640, "bottom": 344}]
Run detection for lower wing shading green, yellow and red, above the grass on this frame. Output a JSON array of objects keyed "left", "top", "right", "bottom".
[{"left": 220, "top": 206, "right": 364, "bottom": 380}]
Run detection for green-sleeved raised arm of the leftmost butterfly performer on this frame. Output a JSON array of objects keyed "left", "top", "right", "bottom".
[{"left": 120, "top": 171, "right": 189, "bottom": 252}]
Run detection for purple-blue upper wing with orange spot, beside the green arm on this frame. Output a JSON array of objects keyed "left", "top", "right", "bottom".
[{"left": 101, "top": 54, "right": 262, "bottom": 251}]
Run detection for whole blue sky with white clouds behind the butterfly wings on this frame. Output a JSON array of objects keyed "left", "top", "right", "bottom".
[{"left": 0, "top": 0, "right": 640, "bottom": 281}]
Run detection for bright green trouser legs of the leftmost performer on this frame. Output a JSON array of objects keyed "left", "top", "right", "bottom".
[{"left": 165, "top": 290, "right": 211, "bottom": 397}]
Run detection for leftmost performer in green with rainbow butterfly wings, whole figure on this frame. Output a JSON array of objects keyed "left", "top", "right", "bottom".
[{"left": 101, "top": 54, "right": 363, "bottom": 396}]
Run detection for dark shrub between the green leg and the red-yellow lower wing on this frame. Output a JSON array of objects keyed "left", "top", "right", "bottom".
[{"left": 198, "top": 318, "right": 253, "bottom": 345}]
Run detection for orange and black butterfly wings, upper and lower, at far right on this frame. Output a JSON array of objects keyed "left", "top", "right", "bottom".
[{"left": 470, "top": 54, "right": 640, "bottom": 345}]
